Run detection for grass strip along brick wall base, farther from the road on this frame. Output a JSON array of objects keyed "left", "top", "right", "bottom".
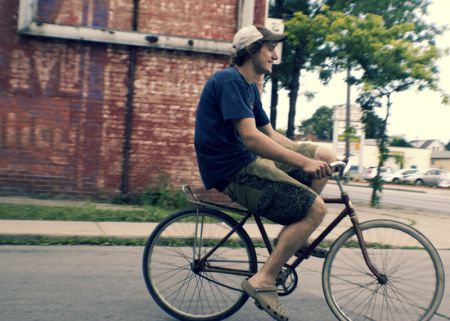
[{"left": 0, "top": 204, "right": 173, "bottom": 222}]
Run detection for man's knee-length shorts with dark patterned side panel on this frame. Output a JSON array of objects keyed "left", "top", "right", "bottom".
[{"left": 223, "top": 144, "right": 317, "bottom": 225}]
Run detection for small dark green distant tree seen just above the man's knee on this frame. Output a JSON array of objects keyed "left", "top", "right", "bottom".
[{"left": 298, "top": 106, "right": 333, "bottom": 141}]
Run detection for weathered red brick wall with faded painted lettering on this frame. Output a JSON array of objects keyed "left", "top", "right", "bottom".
[{"left": 0, "top": 0, "right": 265, "bottom": 196}]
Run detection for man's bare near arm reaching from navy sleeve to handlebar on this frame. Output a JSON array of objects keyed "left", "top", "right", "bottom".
[{"left": 233, "top": 118, "right": 331, "bottom": 179}]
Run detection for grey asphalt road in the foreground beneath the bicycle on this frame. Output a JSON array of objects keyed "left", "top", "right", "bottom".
[{"left": 0, "top": 246, "right": 450, "bottom": 321}]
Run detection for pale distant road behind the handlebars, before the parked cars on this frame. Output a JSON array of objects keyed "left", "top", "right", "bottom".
[{"left": 323, "top": 183, "right": 450, "bottom": 214}]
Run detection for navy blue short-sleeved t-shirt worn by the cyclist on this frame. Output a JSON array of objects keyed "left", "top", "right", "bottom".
[{"left": 195, "top": 67, "right": 269, "bottom": 191}]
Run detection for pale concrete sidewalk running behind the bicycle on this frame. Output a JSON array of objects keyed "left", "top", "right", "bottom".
[{"left": 0, "top": 197, "right": 450, "bottom": 250}]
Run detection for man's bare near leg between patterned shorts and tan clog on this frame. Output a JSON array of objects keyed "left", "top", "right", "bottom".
[{"left": 249, "top": 196, "right": 326, "bottom": 288}]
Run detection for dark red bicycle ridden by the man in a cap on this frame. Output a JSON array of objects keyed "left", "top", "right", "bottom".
[{"left": 143, "top": 161, "right": 445, "bottom": 321}]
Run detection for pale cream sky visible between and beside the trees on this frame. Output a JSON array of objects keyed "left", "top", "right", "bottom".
[{"left": 262, "top": 0, "right": 450, "bottom": 144}]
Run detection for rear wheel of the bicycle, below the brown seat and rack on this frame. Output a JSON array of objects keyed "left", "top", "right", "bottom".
[{"left": 143, "top": 209, "right": 257, "bottom": 321}]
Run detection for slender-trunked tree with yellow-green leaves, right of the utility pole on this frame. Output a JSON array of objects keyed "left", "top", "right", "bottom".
[{"left": 346, "top": 10, "right": 439, "bottom": 205}]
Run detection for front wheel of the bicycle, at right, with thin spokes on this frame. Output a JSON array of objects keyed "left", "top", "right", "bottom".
[{"left": 322, "top": 220, "right": 444, "bottom": 321}]
